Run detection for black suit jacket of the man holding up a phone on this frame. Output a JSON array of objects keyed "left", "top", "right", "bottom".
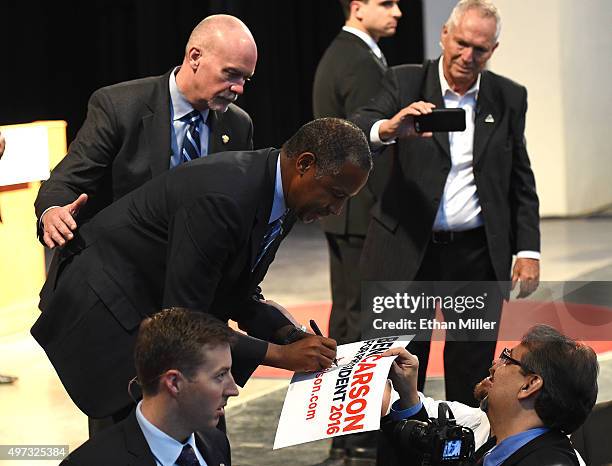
[{"left": 354, "top": 60, "right": 540, "bottom": 281}]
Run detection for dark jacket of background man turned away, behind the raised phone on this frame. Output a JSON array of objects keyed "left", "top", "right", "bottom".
[{"left": 312, "top": 31, "right": 388, "bottom": 235}]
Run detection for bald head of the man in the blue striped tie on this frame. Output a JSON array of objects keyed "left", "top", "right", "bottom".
[{"left": 176, "top": 15, "right": 257, "bottom": 111}]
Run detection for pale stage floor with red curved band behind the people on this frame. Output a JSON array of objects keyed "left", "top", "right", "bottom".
[{"left": 0, "top": 219, "right": 612, "bottom": 466}]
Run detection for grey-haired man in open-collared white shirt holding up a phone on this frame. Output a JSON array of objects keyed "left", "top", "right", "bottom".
[{"left": 354, "top": 0, "right": 540, "bottom": 404}]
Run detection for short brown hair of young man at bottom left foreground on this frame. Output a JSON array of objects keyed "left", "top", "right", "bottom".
[{"left": 134, "top": 307, "right": 235, "bottom": 395}]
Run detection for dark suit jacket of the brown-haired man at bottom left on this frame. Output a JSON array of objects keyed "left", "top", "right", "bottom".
[{"left": 61, "top": 412, "right": 232, "bottom": 466}]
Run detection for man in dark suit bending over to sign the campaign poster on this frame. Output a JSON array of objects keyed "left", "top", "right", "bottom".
[{"left": 32, "top": 118, "right": 372, "bottom": 426}]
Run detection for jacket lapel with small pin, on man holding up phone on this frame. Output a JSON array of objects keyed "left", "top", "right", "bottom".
[{"left": 473, "top": 71, "right": 501, "bottom": 165}]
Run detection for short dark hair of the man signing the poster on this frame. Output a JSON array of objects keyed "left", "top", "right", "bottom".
[{"left": 283, "top": 118, "right": 372, "bottom": 177}]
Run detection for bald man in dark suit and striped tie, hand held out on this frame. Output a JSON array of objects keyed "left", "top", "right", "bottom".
[{"left": 35, "top": 15, "right": 257, "bottom": 248}]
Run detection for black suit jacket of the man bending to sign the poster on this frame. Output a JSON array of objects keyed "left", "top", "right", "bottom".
[{"left": 32, "top": 149, "right": 291, "bottom": 417}]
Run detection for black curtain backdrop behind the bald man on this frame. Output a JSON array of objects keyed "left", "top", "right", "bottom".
[{"left": 0, "top": 0, "right": 423, "bottom": 147}]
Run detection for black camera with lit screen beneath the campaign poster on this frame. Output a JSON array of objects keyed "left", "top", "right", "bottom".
[{"left": 392, "top": 403, "right": 475, "bottom": 466}]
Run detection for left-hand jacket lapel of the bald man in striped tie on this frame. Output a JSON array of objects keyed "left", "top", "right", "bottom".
[{"left": 142, "top": 71, "right": 172, "bottom": 177}]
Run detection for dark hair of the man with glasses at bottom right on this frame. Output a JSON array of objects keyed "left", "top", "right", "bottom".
[{"left": 521, "top": 325, "right": 599, "bottom": 435}]
